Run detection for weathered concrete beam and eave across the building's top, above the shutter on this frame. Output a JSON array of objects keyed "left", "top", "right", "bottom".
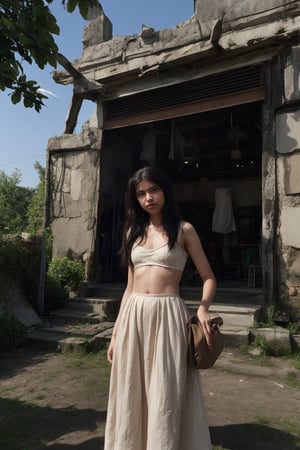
[{"left": 53, "top": 0, "right": 300, "bottom": 110}]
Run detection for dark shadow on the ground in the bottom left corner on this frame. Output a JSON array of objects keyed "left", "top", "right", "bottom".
[{"left": 0, "top": 398, "right": 106, "bottom": 450}]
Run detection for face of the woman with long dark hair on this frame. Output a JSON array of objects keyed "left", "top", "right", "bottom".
[{"left": 136, "top": 180, "right": 165, "bottom": 215}]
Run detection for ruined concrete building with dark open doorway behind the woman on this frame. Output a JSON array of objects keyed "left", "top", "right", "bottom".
[{"left": 47, "top": 0, "right": 300, "bottom": 318}]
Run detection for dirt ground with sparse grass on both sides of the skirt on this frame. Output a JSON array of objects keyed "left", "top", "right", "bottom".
[{"left": 0, "top": 348, "right": 300, "bottom": 450}]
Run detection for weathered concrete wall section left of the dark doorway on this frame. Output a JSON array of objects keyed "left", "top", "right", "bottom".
[{"left": 48, "top": 129, "right": 102, "bottom": 258}]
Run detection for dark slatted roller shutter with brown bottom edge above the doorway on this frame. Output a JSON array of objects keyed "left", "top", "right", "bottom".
[{"left": 104, "top": 65, "right": 264, "bottom": 129}]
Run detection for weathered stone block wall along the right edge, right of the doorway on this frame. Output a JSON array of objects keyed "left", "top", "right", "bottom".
[{"left": 276, "top": 47, "right": 300, "bottom": 316}]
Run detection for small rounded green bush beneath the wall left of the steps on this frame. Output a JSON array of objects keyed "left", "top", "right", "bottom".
[{"left": 48, "top": 256, "right": 84, "bottom": 293}]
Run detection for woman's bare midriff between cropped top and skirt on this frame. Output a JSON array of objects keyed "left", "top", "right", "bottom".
[{"left": 132, "top": 266, "right": 182, "bottom": 294}]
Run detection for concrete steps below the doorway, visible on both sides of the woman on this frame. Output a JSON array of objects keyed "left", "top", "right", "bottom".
[{"left": 27, "top": 284, "right": 262, "bottom": 352}]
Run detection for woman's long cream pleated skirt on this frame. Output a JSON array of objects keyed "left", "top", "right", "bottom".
[{"left": 104, "top": 294, "right": 211, "bottom": 450}]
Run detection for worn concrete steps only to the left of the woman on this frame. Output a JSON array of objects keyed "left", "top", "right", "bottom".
[{"left": 27, "top": 285, "right": 120, "bottom": 352}]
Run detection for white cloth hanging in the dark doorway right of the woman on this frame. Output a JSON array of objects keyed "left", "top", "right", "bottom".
[{"left": 212, "top": 188, "right": 236, "bottom": 234}]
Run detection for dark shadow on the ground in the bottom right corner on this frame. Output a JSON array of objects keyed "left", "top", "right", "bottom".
[{"left": 210, "top": 423, "right": 299, "bottom": 450}]
